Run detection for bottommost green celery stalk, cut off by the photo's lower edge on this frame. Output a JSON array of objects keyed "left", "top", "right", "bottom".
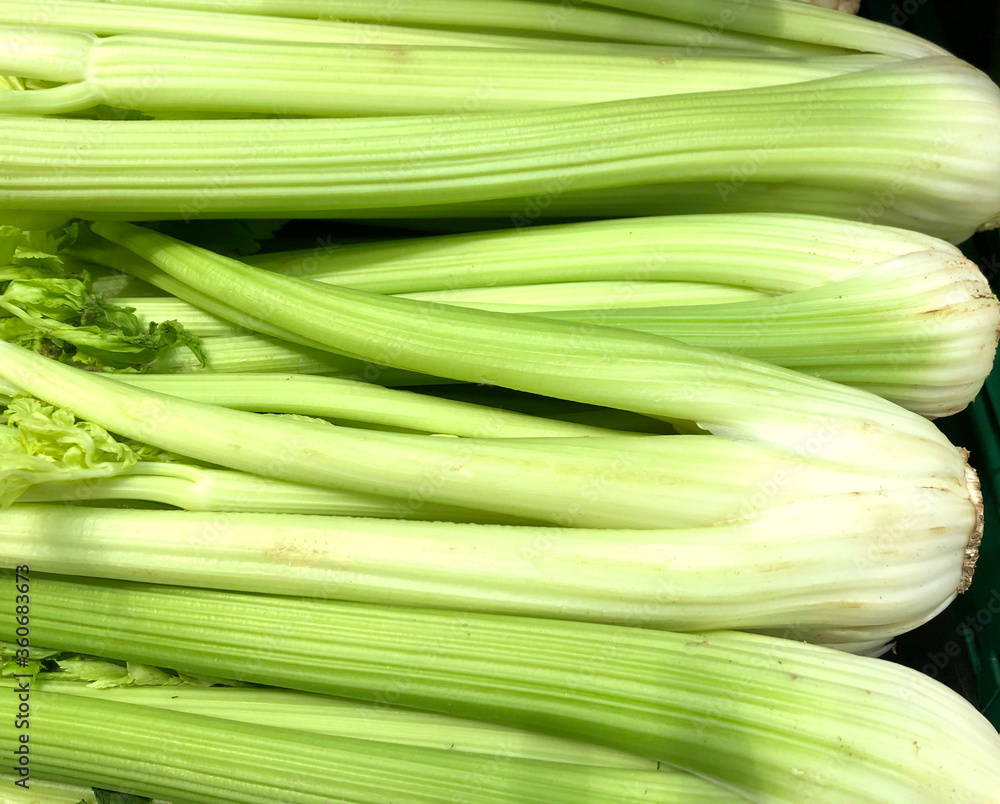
[{"left": 0, "top": 688, "right": 738, "bottom": 804}]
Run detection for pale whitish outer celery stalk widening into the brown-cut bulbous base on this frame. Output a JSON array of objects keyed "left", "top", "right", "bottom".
[{"left": 0, "top": 490, "right": 975, "bottom": 645}]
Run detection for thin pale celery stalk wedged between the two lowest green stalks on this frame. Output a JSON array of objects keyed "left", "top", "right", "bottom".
[{"left": 21, "top": 673, "right": 656, "bottom": 768}]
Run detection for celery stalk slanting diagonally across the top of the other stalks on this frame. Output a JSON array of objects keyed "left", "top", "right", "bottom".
[{"left": 92, "top": 222, "right": 964, "bottom": 483}]
